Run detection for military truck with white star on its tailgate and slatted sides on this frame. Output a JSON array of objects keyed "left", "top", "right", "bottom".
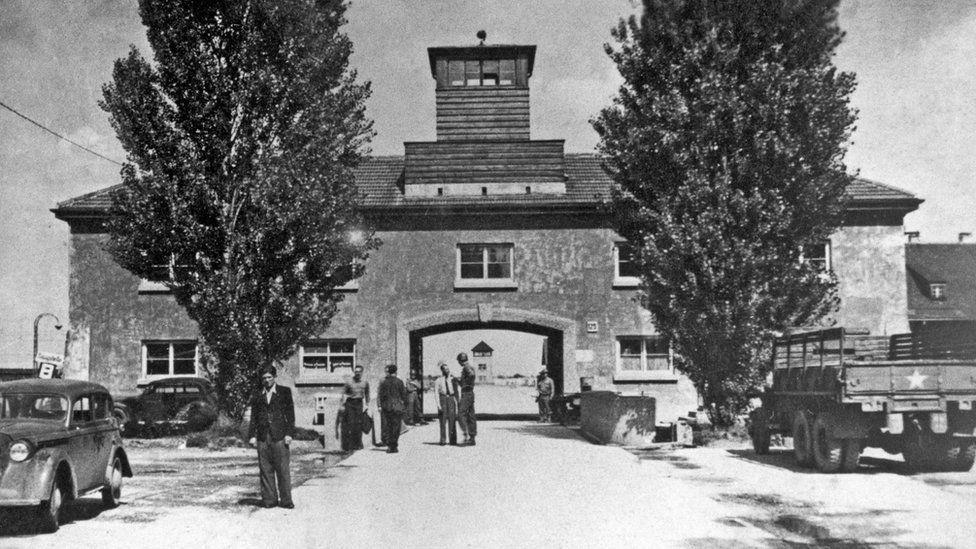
[{"left": 749, "top": 328, "right": 976, "bottom": 473}]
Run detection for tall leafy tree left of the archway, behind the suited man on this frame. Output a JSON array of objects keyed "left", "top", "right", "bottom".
[{"left": 100, "top": 0, "right": 378, "bottom": 419}]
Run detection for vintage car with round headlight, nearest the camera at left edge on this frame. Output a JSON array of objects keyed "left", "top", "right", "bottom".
[{"left": 0, "top": 379, "right": 132, "bottom": 532}]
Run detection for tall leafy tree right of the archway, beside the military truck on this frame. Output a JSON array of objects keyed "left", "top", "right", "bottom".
[{"left": 593, "top": 0, "right": 856, "bottom": 424}]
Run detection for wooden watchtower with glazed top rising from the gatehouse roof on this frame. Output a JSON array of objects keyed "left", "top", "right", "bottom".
[{"left": 403, "top": 31, "right": 566, "bottom": 199}]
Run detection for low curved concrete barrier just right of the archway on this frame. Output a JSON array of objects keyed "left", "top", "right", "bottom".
[{"left": 580, "top": 391, "right": 655, "bottom": 446}]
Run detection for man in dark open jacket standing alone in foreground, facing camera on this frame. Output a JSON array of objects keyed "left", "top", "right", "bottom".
[{"left": 248, "top": 366, "right": 295, "bottom": 509}]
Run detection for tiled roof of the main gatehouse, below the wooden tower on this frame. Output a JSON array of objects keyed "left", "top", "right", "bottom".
[{"left": 55, "top": 154, "right": 921, "bottom": 215}]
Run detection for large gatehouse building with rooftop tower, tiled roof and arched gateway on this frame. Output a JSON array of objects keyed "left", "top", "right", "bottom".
[{"left": 53, "top": 40, "right": 921, "bottom": 425}]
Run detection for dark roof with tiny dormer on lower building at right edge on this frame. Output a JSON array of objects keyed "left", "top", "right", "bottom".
[{"left": 905, "top": 243, "right": 976, "bottom": 320}]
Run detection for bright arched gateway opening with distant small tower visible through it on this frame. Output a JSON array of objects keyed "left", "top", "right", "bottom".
[{"left": 410, "top": 321, "right": 563, "bottom": 419}]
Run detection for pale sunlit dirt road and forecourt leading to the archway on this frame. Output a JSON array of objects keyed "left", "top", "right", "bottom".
[{"left": 0, "top": 422, "right": 976, "bottom": 548}]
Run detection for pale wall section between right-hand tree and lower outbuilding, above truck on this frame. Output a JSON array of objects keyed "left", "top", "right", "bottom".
[{"left": 830, "top": 225, "right": 908, "bottom": 335}]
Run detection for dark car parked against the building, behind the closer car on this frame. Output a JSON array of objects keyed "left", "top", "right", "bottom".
[{"left": 113, "top": 376, "right": 217, "bottom": 431}]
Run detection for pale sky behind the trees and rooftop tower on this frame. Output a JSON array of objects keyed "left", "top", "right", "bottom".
[{"left": 0, "top": 0, "right": 976, "bottom": 367}]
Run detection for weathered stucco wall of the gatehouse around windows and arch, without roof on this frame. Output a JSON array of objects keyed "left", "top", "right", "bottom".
[{"left": 67, "top": 212, "right": 908, "bottom": 431}]
